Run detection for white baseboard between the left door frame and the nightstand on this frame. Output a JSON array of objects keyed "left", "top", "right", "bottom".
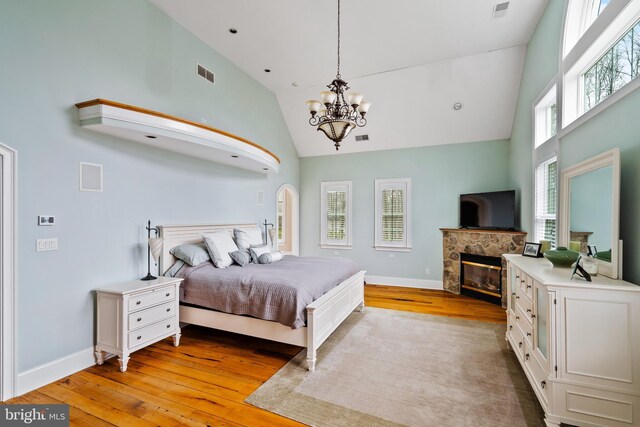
[{"left": 16, "top": 347, "right": 96, "bottom": 396}]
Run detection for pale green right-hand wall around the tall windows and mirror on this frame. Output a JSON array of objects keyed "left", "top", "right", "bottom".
[{"left": 510, "top": 0, "right": 640, "bottom": 284}]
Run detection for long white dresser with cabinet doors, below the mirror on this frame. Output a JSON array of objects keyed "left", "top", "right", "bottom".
[{"left": 504, "top": 255, "right": 640, "bottom": 427}]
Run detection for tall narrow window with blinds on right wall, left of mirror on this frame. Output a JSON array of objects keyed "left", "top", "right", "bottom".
[{"left": 534, "top": 157, "right": 558, "bottom": 247}]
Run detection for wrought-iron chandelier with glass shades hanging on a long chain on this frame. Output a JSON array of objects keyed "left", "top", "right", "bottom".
[{"left": 307, "top": 0, "right": 371, "bottom": 151}]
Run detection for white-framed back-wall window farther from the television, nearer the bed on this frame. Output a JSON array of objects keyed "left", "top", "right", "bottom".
[{"left": 320, "top": 181, "right": 352, "bottom": 249}]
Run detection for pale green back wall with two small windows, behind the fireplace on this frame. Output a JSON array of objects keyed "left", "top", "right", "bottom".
[{"left": 300, "top": 141, "right": 510, "bottom": 280}]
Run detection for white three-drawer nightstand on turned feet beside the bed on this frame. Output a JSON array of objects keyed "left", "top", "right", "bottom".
[{"left": 95, "top": 277, "right": 182, "bottom": 372}]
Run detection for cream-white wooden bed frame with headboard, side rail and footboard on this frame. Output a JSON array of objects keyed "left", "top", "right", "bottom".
[{"left": 158, "top": 224, "right": 365, "bottom": 371}]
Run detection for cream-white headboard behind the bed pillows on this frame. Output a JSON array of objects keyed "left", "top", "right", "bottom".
[{"left": 158, "top": 224, "right": 259, "bottom": 274}]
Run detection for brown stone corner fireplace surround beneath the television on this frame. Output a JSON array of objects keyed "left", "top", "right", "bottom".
[{"left": 440, "top": 228, "right": 527, "bottom": 306}]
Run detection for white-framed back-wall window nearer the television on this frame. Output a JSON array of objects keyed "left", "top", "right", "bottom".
[{"left": 375, "top": 178, "right": 411, "bottom": 251}]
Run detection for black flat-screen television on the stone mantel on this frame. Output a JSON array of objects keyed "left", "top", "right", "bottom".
[{"left": 460, "top": 190, "right": 516, "bottom": 230}]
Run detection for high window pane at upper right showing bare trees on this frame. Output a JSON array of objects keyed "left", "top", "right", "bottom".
[{"left": 582, "top": 22, "right": 640, "bottom": 111}]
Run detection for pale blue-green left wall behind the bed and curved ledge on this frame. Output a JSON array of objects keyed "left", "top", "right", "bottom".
[{"left": 0, "top": 0, "right": 299, "bottom": 372}]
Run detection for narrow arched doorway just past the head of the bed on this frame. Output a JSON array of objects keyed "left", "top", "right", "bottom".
[{"left": 276, "top": 184, "right": 300, "bottom": 255}]
